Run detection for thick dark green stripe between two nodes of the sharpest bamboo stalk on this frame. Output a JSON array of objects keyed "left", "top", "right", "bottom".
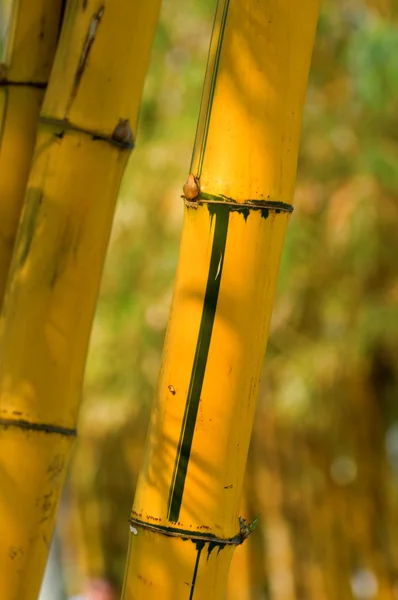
[{"left": 167, "top": 205, "right": 229, "bottom": 523}]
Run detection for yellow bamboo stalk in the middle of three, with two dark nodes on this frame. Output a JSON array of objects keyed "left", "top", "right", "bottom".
[{"left": 0, "top": 0, "right": 160, "bottom": 600}]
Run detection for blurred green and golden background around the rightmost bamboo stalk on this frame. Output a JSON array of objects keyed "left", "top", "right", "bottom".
[{"left": 38, "top": 0, "right": 398, "bottom": 600}]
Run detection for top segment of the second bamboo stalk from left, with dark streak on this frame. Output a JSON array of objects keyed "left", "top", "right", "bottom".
[{"left": 43, "top": 0, "right": 160, "bottom": 134}]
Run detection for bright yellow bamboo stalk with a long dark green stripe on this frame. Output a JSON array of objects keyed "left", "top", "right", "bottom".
[{"left": 122, "top": 0, "right": 319, "bottom": 600}]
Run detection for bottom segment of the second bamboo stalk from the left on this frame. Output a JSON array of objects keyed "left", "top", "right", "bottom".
[{"left": 0, "top": 427, "right": 73, "bottom": 600}]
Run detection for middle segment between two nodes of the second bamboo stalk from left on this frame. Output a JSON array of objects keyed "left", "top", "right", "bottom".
[{"left": 0, "top": 128, "right": 128, "bottom": 428}]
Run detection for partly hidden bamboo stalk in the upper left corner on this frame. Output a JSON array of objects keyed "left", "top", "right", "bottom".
[{"left": 0, "top": 0, "right": 62, "bottom": 310}]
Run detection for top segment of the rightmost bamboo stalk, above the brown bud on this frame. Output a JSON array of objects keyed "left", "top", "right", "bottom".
[{"left": 192, "top": 0, "right": 319, "bottom": 203}]
